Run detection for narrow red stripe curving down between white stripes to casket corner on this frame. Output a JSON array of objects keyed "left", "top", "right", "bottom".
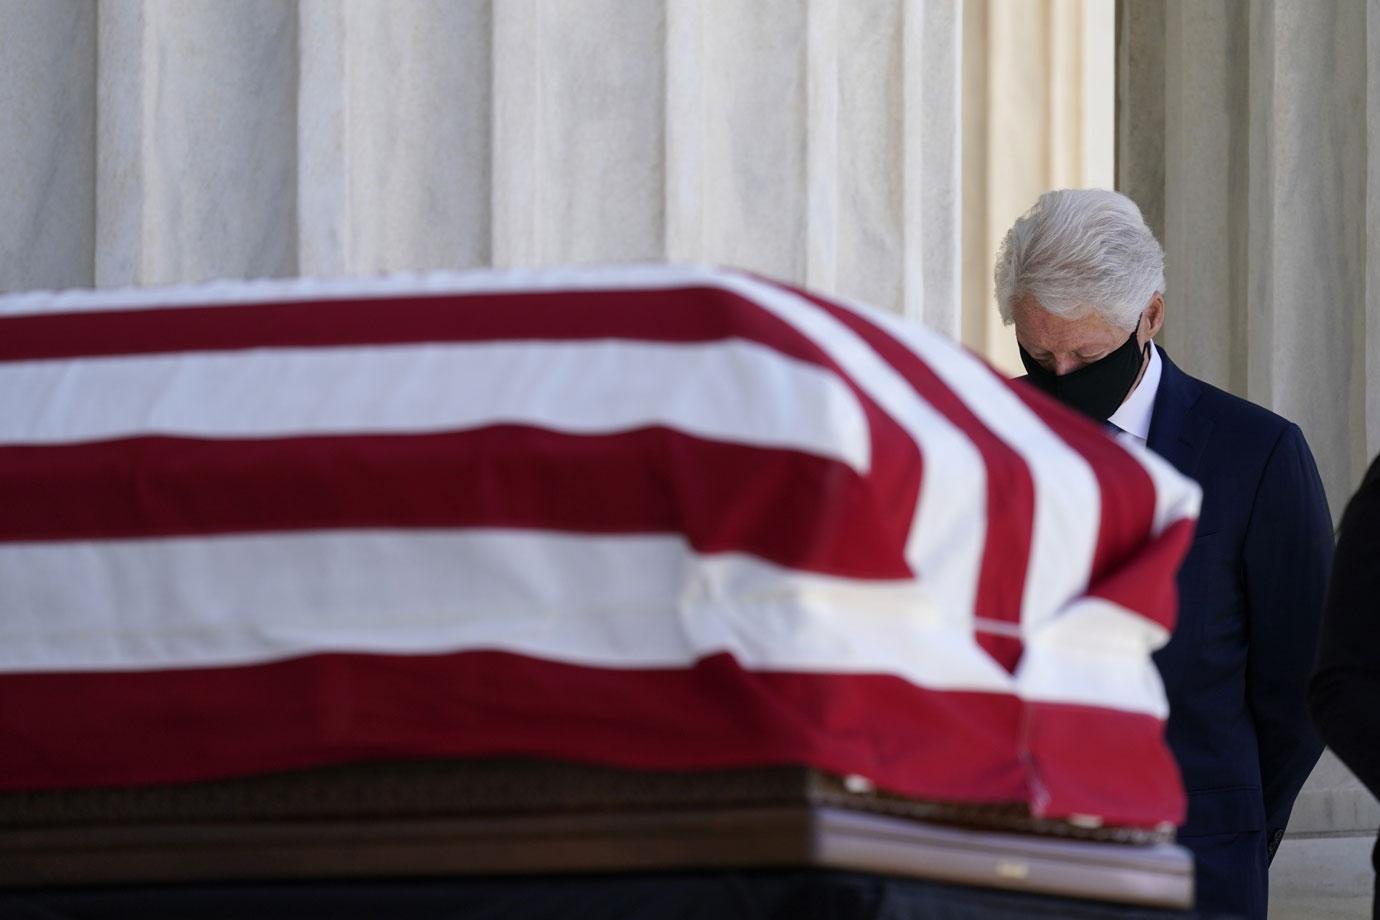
[{"left": 788, "top": 288, "right": 1035, "bottom": 673}]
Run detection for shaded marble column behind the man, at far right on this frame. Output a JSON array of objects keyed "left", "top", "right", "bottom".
[{"left": 1118, "top": 0, "right": 1380, "bottom": 916}]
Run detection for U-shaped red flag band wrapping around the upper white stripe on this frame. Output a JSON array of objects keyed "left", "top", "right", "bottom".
[{"left": 0, "top": 287, "right": 920, "bottom": 578}]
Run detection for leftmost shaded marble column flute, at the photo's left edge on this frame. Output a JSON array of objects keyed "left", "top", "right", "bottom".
[{"left": 0, "top": 0, "right": 97, "bottom": 291}]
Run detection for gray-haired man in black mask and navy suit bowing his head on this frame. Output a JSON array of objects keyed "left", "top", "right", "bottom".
[{"left": 996, "top": 189, "right": 1332, "bottom": 920}]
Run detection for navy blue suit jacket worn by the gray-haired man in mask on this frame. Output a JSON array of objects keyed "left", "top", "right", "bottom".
[{"left": 1148, "top": 350, "right": 1333, "bottom": 854}]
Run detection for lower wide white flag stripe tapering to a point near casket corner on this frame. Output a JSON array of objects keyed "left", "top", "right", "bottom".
[{"left": 0, "top": 530, "right": 1014, "bottom": 692}]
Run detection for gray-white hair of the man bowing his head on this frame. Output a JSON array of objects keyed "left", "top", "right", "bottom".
[{"left": 995, "top": 189, "right": 1165, "bottom": 331}]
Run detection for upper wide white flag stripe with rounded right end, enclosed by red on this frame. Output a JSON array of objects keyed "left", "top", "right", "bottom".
[{"left": 0, "top": 339, "right": 871, "bottom": 473}]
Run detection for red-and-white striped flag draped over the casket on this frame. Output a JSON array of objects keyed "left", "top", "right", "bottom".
[{"left": 0, "top": 266, "right": 1198, "bottom": 826}]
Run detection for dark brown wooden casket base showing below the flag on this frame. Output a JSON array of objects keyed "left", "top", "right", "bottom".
[{"left": 0, "top": 760, "right": 1192, "bottom": 908}]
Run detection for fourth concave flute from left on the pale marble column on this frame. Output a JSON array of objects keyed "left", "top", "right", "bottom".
[{"left": 493, "top": 0, "right": 672, "bottom": 266}]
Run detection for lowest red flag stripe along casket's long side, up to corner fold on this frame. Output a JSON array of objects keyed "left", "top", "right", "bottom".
[{"left": 0, "top": 651, "right": 1027, "bottom": 801}]
